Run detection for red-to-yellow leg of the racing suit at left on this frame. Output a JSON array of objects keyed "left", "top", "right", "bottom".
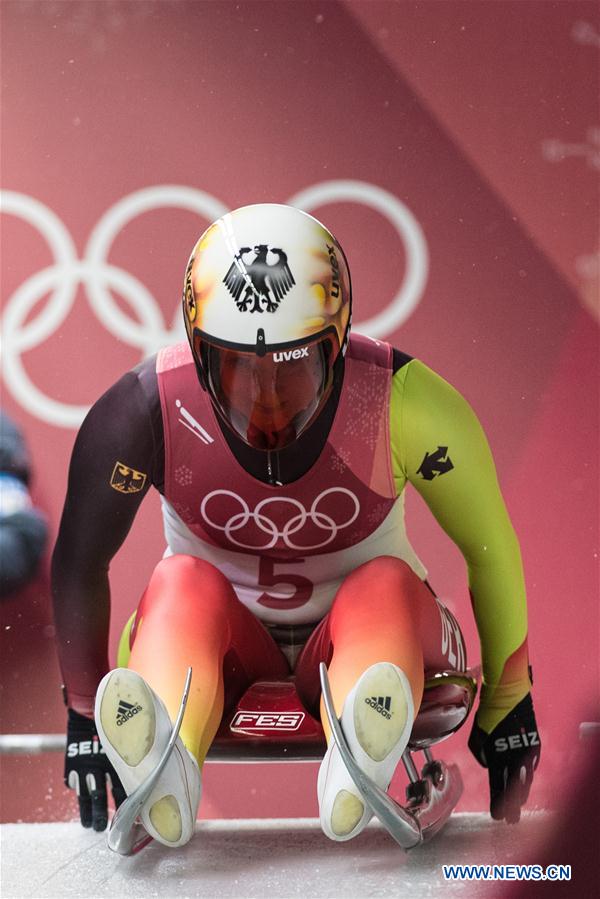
[{"left": 129, "top": 555, "right": 289, "bottom": 765}]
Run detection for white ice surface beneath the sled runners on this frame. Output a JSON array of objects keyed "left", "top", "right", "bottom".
[{"left": 0, "top": 813, "right": 549, "bottom": 899}]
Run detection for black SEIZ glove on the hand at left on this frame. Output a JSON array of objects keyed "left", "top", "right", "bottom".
[{"left": 65, "top": 709, "right": 126, "bottom": 830}]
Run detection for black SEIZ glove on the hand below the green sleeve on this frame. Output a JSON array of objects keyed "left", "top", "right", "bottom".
[{"left": 469, "top": 693, "right": 541, "bottom": 824}]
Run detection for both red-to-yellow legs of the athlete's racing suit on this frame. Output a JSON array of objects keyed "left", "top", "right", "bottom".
[{"left": 129, "top": 555, "right": 464, "bottom": 765}]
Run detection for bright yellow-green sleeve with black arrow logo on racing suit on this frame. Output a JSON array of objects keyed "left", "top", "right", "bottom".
[{"left": 391, "top": 360, "right": 530, "bottom": 732}]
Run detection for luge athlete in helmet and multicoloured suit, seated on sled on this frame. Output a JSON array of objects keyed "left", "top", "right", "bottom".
[{"left": 53, "top": 204, "right": 539, "bottom": 846}]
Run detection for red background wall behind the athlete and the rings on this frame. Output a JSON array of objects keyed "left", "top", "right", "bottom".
[{"left": 1, "top": 0, "right": 600, "bottom": 820}]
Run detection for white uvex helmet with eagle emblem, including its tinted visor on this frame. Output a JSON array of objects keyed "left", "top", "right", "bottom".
[{"left": 183, "top": 203, "right": 351, "bottom": 450}]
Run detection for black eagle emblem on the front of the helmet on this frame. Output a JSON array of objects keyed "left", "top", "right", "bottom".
[{"left": 223, "top": 243, "right": 296, "bottom": 312}]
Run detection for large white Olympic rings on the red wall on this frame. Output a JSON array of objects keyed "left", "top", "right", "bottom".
[{"left": 0, "top": 181, "right": 428, "bottom": 428}]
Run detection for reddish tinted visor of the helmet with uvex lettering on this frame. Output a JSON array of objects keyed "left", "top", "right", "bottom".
[{"left": 200, "top": 334, "right": 337, "bottom": 450}]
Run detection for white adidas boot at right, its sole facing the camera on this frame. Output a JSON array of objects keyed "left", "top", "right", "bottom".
[{"left": 317, "top": 662, "right": 414, "bottom": 841}]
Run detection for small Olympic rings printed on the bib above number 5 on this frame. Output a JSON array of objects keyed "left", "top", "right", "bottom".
[{"left": 200, "top": 487, "right": 360, "bottom": 551}]
